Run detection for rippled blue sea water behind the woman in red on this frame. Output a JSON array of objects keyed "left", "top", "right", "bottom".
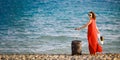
[{"left": 0, "top": 0, "right": 120, "bottom": 54}]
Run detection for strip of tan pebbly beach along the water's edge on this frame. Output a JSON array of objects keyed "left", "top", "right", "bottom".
[{"left": 0, "top": 53, "right": 120, "bottom": 60}]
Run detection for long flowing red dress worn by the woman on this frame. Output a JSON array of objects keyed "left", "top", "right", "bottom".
[{"left": 87, "top": 19, "right": 102, "bottom": 54}]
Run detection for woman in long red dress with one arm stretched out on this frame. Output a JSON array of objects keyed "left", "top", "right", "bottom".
[{"left": 75, "top": 12, "right": 102, "bottom": 55}]
